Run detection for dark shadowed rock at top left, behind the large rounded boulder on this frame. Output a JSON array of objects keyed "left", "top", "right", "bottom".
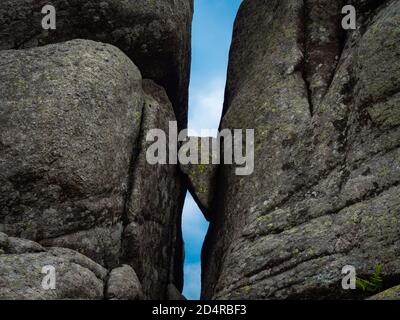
[{"left": 0, "top": 0, "right": 193, "bottom": 127}]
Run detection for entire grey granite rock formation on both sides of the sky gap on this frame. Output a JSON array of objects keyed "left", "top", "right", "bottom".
[{"left": 0, "top": 0, "right": 400, "bottom": 300}]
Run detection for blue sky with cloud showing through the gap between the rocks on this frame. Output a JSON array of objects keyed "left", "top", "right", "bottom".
[{"left": 182, "top": 0, "right": 242, "bottom": 300}]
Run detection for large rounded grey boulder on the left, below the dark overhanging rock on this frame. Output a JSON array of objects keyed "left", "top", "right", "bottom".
[{"left": 0, "top": 40, "right": 143, "bottom": 266}]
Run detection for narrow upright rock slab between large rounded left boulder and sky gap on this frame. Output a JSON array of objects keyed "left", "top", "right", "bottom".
[{"left": 122, "top": 80, "right": 185, "bottom": 299}]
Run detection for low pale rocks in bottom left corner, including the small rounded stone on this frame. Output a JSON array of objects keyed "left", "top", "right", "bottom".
[{"left": 0, "top": 233, "right": 145, "bottom": 300}]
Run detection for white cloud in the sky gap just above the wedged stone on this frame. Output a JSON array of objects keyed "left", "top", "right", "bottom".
[{"left": 189, "top": 77, "right": 225, "bottom": 136}]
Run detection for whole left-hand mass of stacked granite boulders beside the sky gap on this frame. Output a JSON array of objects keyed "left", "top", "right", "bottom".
[{"left": 0, "top": 0, "right": 193, "bottom": 299}]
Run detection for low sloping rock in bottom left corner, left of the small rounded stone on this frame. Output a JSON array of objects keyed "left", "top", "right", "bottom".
[{"left": 0, "top": 233, "right": 107, "bottom": 300}]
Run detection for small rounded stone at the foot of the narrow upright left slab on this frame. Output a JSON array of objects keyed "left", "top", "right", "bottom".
[{"left": 105, "top": 265, "right": 143, "bottom": 300}]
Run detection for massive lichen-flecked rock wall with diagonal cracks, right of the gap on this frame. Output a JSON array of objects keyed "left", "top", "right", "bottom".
[{"left": 202, "top": 0, "right": 400, "bottom": 299}]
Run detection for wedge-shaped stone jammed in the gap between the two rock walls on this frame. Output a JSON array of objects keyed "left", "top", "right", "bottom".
[{"left": 180, "top": 137, "right": 219, "bottom": 220}]
